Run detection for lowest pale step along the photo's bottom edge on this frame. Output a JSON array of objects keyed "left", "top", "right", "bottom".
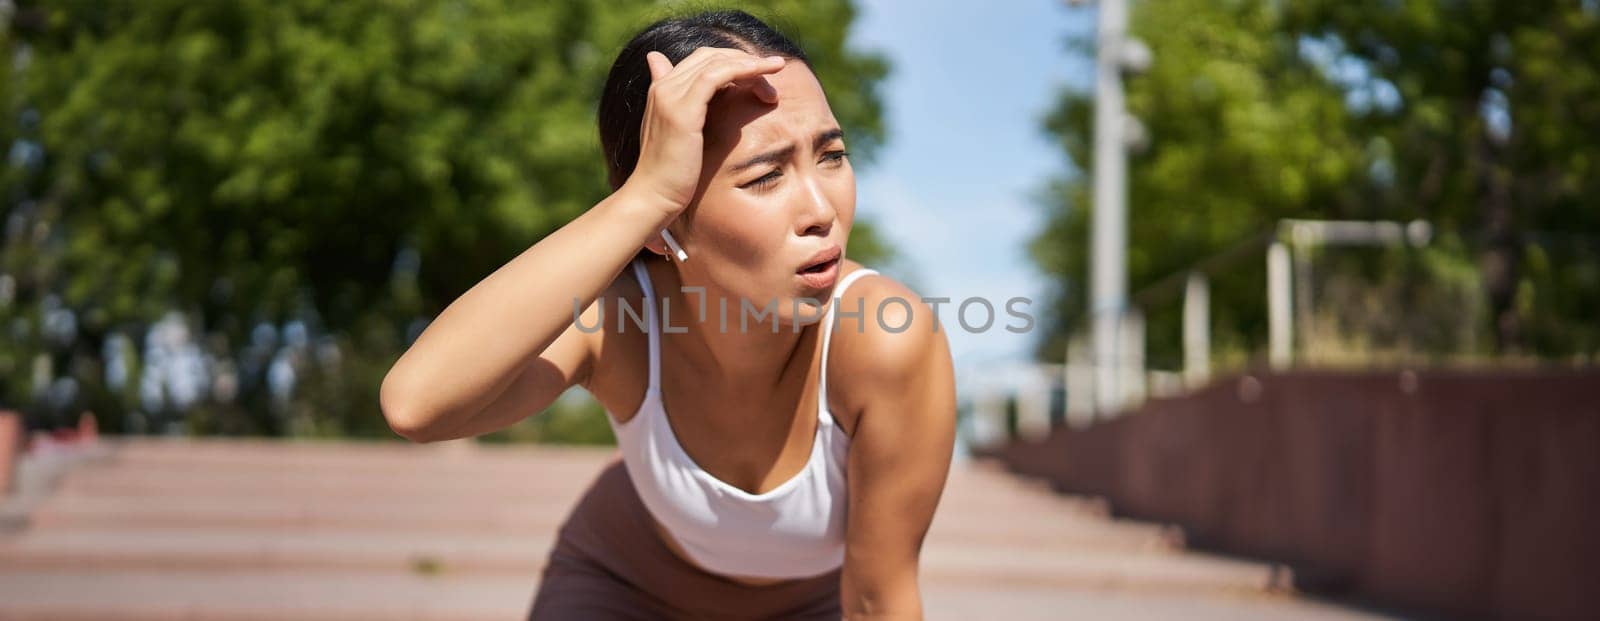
[{"left": 0, "top": 570, "right": 1378, "bottom": 621}]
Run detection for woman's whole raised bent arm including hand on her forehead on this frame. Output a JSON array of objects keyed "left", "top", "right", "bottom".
[{"left": 379, "top": 48, "right": 784, "bottom": 442}]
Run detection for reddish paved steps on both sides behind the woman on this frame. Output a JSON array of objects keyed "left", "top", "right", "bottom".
[{"left": 0, "top": 440, "right": 1371, "bottom": 619}]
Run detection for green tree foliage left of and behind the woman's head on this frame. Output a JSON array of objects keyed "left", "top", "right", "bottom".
[{"left": 0, "top": 0, "right": 886, "bottom": 432}]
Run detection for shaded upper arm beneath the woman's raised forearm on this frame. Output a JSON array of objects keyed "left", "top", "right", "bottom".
[{"left": 419, "top": 294, "right": 608, "bottom": 439}]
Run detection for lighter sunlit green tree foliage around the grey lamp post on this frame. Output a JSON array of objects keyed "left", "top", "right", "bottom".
[{"left": 1032, "top": 0, "right": 1362, "bottom": 359}]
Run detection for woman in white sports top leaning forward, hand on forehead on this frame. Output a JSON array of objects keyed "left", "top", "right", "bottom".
[{"left": 381, "top": 11, "right": 955, "bottom": 619}]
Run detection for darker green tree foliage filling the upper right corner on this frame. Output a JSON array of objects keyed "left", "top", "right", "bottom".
[{"left": 1286, "top": 2, "right": 1600, "bottom": 354}]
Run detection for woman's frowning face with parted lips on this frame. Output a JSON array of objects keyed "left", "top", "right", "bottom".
[{"left": 678, "top": 61, "right": 856, "bottom": 330}]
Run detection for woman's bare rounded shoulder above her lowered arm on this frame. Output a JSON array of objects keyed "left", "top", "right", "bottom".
[{"left": 829, "top": 266, "right": 954, "bottom": 425}]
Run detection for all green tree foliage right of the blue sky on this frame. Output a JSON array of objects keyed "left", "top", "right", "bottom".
[{"left": 1032, "top": 0, "right": 1600, "bottom": 362}]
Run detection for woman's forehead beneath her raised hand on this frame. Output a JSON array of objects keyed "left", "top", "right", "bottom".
[{"left": 706, "top": 59, "right": 838, "bottom": 154}]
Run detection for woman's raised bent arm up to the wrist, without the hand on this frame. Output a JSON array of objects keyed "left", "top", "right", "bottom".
[{"left": 379, "top": 189, "right": 666, "bottom": 442}]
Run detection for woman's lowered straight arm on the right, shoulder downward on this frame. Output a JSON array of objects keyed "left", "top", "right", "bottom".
[{"left": 834, "top": 278, "right": 955, "bottom": 618}]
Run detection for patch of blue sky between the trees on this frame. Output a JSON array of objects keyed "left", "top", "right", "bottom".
[{"left": 851, "top": 0, "right": 1094, "bottom": 376}]
